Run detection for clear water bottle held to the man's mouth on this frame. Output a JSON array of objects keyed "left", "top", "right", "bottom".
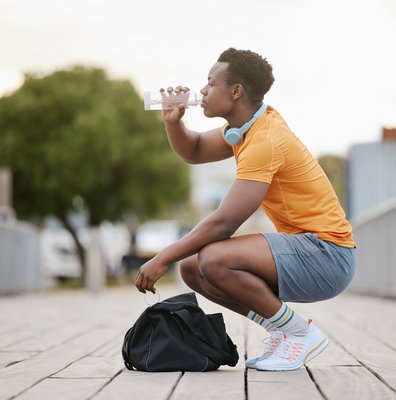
[{"left": 144, "top": 91, "right": 202, "bottom": 110}]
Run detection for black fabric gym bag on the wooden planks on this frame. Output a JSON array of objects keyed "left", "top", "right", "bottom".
[{"left": 122, "top": 293, "right": 239, "bottom": 372}]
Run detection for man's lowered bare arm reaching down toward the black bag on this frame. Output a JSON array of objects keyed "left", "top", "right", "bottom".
[{"left": 136, "top": 179, "right": 269, "bottom": 293}]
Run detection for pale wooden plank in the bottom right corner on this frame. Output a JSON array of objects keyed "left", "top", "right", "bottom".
[{"left": 310, "top": 366, "right": 396, "bottom": 400}]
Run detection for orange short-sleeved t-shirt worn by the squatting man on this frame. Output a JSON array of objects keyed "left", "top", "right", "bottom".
[{"left": 232, "top": 106, "right": 356, "bottom": 247}]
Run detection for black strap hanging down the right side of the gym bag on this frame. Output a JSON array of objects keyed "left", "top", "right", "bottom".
[{"left": 169, "top": 313, "right": 235, "bottom": 365}]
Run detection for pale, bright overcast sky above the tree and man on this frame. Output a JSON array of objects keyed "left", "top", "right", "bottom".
[{"left": 0, "top": 0, "right": 396, "bottom": 156}]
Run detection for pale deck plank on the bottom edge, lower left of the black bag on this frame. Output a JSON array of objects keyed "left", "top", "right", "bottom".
[{"left": 17, "top": 378, "right": 109, "bottom": 400}]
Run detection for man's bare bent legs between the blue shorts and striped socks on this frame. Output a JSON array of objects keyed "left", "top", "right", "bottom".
[{"left": 181, "top": 234, "right": 281, "bottom": 317}]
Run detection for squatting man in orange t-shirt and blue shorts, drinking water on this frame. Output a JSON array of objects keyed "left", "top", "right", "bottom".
[{"left": 136, "top": 48, "right": 355, "bottom": 371}]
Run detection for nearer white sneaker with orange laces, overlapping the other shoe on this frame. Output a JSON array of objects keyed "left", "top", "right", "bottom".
[{"left": 255, "top": 323, "right": 329, "bottom": 371}]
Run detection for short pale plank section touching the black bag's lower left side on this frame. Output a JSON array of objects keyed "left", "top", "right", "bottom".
[{"left": 52, "top": 355, "right": 124, "bottom": 378}]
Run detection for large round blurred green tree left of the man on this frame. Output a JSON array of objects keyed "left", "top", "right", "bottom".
[{"left": 0, "top": 67, "right": 189, "bottom": 274}]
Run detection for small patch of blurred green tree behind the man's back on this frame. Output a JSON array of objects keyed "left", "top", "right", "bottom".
[{"left": 318, "top": 154, "right": 346, "bottom": 207}]
